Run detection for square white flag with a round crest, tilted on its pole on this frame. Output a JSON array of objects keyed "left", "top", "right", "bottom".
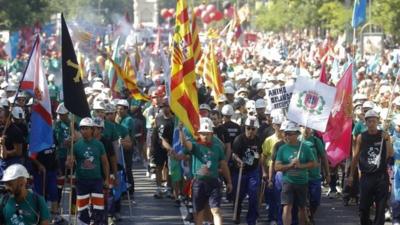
[{"left": 288, "top": 77, "right": 336, "bottom": 132}]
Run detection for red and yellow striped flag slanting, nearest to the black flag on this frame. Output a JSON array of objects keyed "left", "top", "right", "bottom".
[{"left": 108, "top": 56, "right": 150, "bottom": 101}]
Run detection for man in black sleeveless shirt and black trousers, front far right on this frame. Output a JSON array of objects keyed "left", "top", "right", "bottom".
[{"left": 348, "top": 109, "right": 393, "bottom": 224}]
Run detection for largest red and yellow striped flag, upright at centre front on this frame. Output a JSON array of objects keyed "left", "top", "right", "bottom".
[{"left": 170, "top": 0, "right": 200, "bottom": 135}]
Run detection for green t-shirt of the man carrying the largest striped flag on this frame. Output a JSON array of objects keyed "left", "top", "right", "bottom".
[{"left": 185, "top": 136, "right": 225, "bottom": 179}]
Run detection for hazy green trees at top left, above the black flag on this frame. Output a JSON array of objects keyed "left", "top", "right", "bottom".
[{"left": 0, "top": 0, "right": 133, "bottom": 30}]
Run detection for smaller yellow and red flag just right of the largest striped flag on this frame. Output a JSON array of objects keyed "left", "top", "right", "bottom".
[{"left": 203, "top": 42, "right": 224, "bottom": 102}]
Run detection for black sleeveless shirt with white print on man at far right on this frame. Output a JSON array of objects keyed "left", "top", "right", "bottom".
[{"left": 359, "top": 131, "right": 387, "bottom": 174}]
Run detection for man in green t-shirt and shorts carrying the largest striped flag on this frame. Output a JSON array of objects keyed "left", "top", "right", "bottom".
[{"left": 179, "top": 118, "right": 232, "bottom": 225}]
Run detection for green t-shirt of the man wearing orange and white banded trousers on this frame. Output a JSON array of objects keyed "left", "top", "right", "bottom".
[{"left": 74, "top": 138, "right": 106, "bottom": 179}]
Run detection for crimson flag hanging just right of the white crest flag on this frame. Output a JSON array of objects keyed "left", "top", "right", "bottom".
[{"left": 323, "top": 64, "right": 353, "bottom": 166}]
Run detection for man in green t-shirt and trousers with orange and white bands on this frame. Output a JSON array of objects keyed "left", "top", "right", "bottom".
[{"left": 67, "top": 117, "right": 110, "bottom": 224}]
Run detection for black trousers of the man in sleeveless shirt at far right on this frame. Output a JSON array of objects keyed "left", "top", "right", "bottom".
[{"left": 359, "top": 173, "right": 389, "bottom": 225}]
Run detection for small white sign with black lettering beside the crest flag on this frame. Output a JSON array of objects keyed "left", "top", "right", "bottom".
[{"left": 267, "top": 84, "right": 294, "bottom": 109}]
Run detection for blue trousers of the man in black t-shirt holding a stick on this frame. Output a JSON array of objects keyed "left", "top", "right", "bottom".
[{"left": 233, "top": 169, "right": 260, "bottom": 225}]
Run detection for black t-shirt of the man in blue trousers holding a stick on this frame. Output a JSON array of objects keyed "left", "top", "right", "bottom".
[{"left": 232, "top": 134, "right": 262, "bottom": 172}]
